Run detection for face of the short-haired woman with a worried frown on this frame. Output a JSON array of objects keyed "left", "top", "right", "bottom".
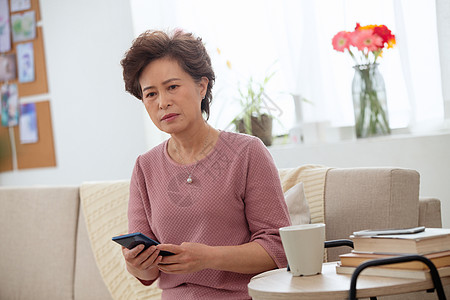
[{"left": 139, "top": 58, "right": 208, "bottom": 134}]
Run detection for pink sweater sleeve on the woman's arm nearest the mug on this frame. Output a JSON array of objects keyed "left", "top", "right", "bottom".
[{"left": 244, "top": 139, "right": 290, "bottom": 268}]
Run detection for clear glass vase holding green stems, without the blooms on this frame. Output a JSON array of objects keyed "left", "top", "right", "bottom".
[{"left": 352, "top": 64, "right": 391, "bottom": 138}]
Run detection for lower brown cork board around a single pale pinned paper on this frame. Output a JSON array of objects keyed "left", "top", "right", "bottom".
[{"left": 14, "top": 101, "right": 56, "bottom": 170}]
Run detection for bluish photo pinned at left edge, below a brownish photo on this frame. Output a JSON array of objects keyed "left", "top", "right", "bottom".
[{"left": 1, "top": 84, "right": 19, "bottom": 127}]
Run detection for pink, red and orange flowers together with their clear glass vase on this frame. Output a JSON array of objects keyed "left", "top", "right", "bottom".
[{"left": 332, "top": 23, "right": 396, "bottom": 138}]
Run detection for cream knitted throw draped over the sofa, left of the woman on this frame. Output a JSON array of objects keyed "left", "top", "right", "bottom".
[{"left": 80, "top": 180, "right": 161, "bottom": 300}]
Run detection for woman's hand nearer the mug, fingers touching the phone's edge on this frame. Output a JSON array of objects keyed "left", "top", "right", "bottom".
[{"left": 156, "top": 242, "right": 214, "bottom": 274}]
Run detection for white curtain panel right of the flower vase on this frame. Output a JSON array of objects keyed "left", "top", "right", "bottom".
[{"left": 394, "top": 0, "right": 444, "bottom": 131}]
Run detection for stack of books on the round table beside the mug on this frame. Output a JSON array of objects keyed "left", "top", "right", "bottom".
[{"left": 336, "top": 228, "right": 450, "bottom": 279}]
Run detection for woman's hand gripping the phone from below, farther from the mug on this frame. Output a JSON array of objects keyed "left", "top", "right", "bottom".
[{"left": 122, "top": 244, "right": 162, "bottom": 281}]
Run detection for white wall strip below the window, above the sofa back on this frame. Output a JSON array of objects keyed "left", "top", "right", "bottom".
[{"left": 270, "top": 133, "right": 450, "bottom": 228}]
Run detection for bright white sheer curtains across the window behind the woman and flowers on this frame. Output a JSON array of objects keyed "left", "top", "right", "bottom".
[{"left": 130, "top": 0, "right": 444, "bottom": 139}]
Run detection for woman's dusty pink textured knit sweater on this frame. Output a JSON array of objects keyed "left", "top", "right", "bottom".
[{"left": 128, "top": 132, "right": 290, "bottom": 299}]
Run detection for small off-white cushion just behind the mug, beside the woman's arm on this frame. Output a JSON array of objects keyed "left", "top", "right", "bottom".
[{"left": 284, "top": 182, "right": 311, "bottom": 225}]
